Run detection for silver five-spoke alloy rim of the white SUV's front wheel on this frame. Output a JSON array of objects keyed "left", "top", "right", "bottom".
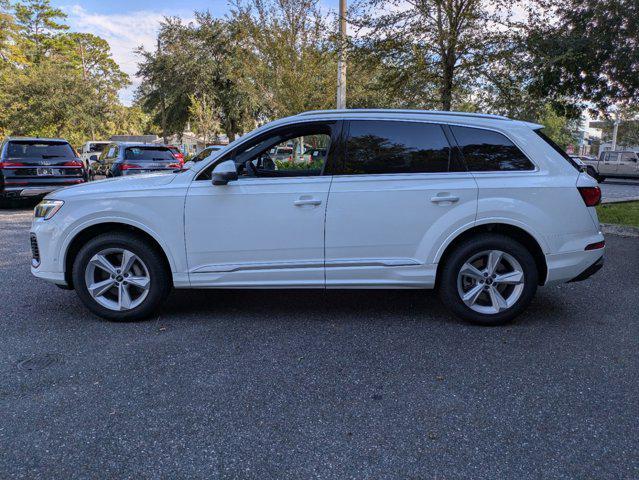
[{"left": 84, "top": 248, "right": 151, "bottom": 311}]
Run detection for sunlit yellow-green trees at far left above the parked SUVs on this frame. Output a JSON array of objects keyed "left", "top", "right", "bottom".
[{"left": 0, "top": 0, "right": 139, "bottom": 145}]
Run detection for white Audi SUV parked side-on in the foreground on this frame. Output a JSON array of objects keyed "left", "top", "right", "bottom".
[{"left": 31, "top": 110, "right": 604, "bottom": 325}]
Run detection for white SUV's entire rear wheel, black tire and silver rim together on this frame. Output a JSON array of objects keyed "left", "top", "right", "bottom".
[{"left": 439, "top": 234, "right": 538, "bottom": 325}]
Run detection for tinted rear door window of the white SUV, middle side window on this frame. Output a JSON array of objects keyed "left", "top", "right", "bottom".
[{"left": 342, "top": 120, "right": 452, "bottom": 175}]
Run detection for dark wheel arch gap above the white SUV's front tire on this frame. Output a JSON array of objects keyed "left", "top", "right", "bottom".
[{"left": 63, "top": 221, "right": 174, "bottom": 288}]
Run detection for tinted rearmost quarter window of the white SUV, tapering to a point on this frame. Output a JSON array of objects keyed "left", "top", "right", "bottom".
[{"left": 450, "top": 126, "right": 535, "bottom": 172}]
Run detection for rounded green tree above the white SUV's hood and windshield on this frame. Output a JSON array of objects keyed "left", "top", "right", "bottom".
[{"left": 137, "top": 12, "right": 257, "bottom": 138}]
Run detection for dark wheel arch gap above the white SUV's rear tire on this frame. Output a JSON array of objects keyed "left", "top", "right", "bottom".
[{"left": 435, "top": 222, "right": 548, "bottom": 285}]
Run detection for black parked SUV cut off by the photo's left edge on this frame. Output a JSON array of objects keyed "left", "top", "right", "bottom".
[{"left": 0, "top": 137, "right": 87, "bottom": 199}]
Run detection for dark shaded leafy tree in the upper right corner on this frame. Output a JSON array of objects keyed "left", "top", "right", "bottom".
[{"left": 528, "top": 0, "right": 639, "bottom": 111}]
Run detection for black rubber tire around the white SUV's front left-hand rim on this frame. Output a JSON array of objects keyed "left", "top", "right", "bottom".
[{"left": 72, "top": 232, "right": 172, "bottom": 322}]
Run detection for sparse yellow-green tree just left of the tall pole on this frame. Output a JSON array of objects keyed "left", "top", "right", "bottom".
[{"left": 231, "top": 0, "right": 337, "bottom": 118}]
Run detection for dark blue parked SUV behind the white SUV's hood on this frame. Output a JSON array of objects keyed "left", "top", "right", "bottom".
[{"left": 90, "top": 142, "right": 182, "bottom": 177}]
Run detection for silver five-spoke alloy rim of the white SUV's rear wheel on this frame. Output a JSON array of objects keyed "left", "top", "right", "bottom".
[{"left": 457, "top": 250, "right": 525, "bottom": 315}]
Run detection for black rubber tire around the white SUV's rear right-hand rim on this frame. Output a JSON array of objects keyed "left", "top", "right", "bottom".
[{"left": 438, "top": 233, "right": 539, "bottom": 326}]
